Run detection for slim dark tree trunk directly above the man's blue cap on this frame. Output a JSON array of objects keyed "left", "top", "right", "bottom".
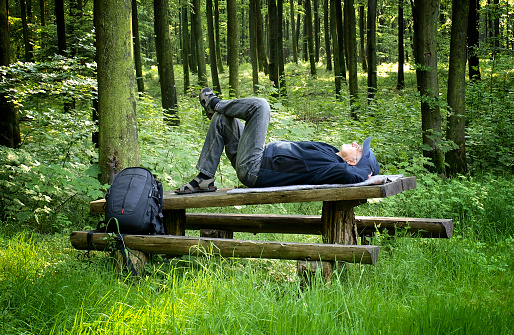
[{"left": 366, "top": 0, "right": 378, "bottom": 103}]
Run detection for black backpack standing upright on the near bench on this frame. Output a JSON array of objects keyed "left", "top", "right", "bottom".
[{"left": 105, "top": 167, "right": 165, "bottom": 235}]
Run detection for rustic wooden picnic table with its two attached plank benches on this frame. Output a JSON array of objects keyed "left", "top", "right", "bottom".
[{"left": 70, "top": 176, "right": 453, "bottom": 276}]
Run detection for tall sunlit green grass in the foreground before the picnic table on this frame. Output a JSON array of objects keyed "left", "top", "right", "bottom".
[{"left": 0, "top": 230, "right": 514, "bottom": 334}]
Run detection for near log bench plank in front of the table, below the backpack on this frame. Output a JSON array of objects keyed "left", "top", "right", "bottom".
[{"left": 70, "top": 231, "right": 379, "bottom": 265}]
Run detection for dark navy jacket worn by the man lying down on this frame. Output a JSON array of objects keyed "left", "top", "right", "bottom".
[{"left": 255, "top": 141, "right": 371, "bottom": 187}]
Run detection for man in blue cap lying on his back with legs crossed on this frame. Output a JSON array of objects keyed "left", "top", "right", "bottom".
[{"left": 175, "top": 87, "right": 380, "bottom": 194}]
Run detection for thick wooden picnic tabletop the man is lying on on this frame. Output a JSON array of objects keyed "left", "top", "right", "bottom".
[{"left": 91, "top": 177, "right": 416, "bottom": 214}]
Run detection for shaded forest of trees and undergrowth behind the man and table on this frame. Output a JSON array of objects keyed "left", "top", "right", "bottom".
[{"left": 0, "top": 0, "right": 514, "bottom": 230}]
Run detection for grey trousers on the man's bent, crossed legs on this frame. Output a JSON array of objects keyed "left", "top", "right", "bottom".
[{"left": 196, "top": 98, "right": 270, "bottom": 187}]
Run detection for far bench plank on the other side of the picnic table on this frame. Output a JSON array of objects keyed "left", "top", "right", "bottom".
[{"left": 186, "top": 213, "right": 453, "bottom": 238}]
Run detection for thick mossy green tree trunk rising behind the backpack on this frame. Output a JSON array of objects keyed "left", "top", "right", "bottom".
[{"left": 95, "top": 0, "right": 139, "bottom": 184}]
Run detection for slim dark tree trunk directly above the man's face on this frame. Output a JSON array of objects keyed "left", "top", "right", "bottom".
[{"left": 344, "top": 0, "right": 359, "bottom": 119}]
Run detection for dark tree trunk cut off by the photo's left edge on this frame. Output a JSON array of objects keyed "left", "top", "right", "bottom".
[{"left": 0, "top": 0, "right": 21, "bottom": 148}]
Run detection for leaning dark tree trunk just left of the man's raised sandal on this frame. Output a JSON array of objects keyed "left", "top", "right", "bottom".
[{"left": 154, "top": 0, "right": 180, "bottom": 126}]
